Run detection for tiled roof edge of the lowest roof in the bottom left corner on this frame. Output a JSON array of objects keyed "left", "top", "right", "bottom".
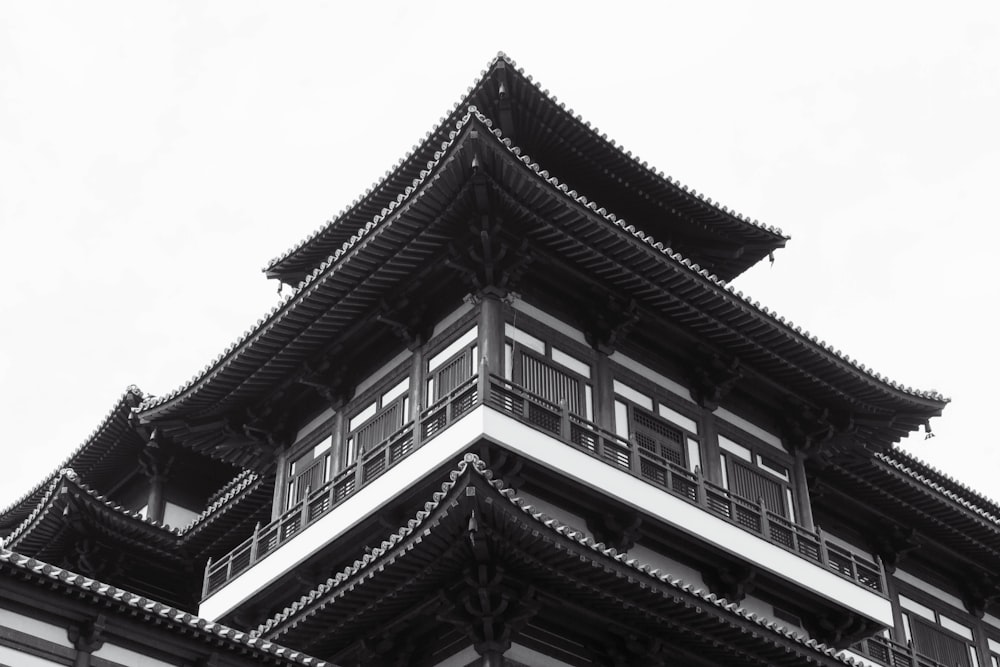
[{"left": 0, "top": 548, "right": 333, "bottom": 667}]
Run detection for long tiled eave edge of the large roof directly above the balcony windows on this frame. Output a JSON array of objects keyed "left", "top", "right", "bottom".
[{"left": 139, "top": 108, "right": 948, "bottom": 428}]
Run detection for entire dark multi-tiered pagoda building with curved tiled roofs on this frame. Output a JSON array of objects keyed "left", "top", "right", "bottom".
[{"left": 7, "top": 54, "right": 1000, "bottom": 667}]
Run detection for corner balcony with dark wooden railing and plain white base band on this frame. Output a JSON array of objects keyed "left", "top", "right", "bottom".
[{"left": 202, "top": 374, "right": 891, "bottom": 624}]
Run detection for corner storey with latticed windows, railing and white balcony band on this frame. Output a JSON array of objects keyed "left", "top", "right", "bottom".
[{"left": 195, "top": 297, "right": 892, "bottom": 639}]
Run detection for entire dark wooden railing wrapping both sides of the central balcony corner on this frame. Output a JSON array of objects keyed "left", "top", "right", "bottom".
[{"left": 203, "top": 372, "right": 884, "bottom": 600}]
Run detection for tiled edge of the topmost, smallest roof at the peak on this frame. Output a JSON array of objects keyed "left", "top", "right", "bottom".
[{"left": 264, "top": 52, "right": 788, "bottom": 280}]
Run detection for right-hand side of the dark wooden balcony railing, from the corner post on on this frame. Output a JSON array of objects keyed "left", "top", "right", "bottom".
[{"left": 485, "top": 375, "right": 886, "bottom": 595}]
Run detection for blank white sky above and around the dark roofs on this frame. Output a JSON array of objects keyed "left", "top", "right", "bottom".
[{"left": 0, "top": 0, "right": 1000, "bottom": 507}]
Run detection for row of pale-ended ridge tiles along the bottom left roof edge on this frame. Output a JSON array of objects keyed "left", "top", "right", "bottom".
[{"left": 0, "top": 547, "right": 326, "bottom": 667}]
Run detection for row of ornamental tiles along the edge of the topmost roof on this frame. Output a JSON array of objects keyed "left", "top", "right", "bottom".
[{"left": 263, "top": 51, "right": 788, "bottom": 272}]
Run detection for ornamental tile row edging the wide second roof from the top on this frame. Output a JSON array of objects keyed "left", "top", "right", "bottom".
[{"left": 137, "top": 105, "right": 950, "bottom": 422}]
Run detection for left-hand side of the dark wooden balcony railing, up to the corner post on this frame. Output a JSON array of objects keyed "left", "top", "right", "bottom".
[{"left": 202, "top": 377, "right": 480, "bottom": 598}]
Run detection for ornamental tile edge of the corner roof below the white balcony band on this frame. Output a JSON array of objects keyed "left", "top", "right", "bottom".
[{"left": 250, "top": 453, "right": 857, "bottom": 665}]
